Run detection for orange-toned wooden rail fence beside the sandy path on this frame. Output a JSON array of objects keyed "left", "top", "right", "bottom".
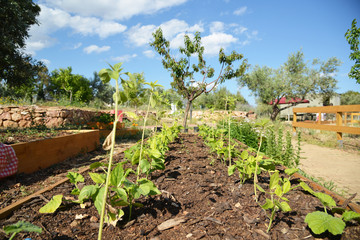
[{"left": 293, "top": 105, "right": 360, "bottom": 141}]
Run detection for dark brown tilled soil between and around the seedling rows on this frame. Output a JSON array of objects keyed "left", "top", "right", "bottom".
[{"left": 0, "top": 134, "right": 360, "bottom": 240}]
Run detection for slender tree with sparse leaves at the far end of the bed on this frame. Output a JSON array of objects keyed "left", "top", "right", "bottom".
[{"left": 150, "top": 28, "right": 247, "bottom": 128}]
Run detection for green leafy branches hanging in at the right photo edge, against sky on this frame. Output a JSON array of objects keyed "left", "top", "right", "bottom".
[{"left": 345, "top": 19, "right": 360, "bottom": 84}]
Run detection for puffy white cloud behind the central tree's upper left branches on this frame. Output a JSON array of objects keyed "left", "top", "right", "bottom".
[{"left": 126, "top": 19, "right": 204, "bottom": 48}]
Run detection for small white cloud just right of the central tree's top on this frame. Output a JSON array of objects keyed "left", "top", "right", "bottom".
[{"left": 202, "top": 33, "right": 238, "bottom": 55}]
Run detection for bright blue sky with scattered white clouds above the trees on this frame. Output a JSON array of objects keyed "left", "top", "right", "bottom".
[{"left": 26, "top": 0, "right": 360, "bottom": 105}]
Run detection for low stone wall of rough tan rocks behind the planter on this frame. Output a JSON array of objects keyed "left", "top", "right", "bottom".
[{"left": 0, "top": 106, "right": 100, "bottom": 128}]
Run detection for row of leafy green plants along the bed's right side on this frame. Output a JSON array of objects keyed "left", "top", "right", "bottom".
[{"left": 199, "top": 120, "right": 360, "bottom": 235}]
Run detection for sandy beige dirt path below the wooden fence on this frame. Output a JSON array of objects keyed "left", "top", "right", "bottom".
[{"left": 300, "top": 143, "right": 360, "bottom": 204}]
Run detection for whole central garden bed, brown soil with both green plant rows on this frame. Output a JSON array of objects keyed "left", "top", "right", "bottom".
[{"left": 0, "top": 121, "right": 359, "bottom": 239}]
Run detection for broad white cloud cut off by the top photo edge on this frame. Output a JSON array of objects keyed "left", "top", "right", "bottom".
[{"left": 44, "top": 0, "right": 187, "bottom": 20}]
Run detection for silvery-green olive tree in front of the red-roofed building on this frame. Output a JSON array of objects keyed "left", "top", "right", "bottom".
[{"left": 238, "top": 51, "right": 340, "bottom": 121}]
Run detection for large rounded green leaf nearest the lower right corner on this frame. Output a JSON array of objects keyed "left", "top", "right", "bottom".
[{"left": 305, "top": 211, "right": 346, "bottom": 235}]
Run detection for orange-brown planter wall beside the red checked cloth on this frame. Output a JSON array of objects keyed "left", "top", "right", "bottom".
[{"left": 11, "top": 130, "right": 100, "bottom": 173}]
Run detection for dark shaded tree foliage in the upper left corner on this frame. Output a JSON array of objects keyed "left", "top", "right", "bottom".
[{"left": 0, "top": 0, "right": 40, "bottom": 88}]
